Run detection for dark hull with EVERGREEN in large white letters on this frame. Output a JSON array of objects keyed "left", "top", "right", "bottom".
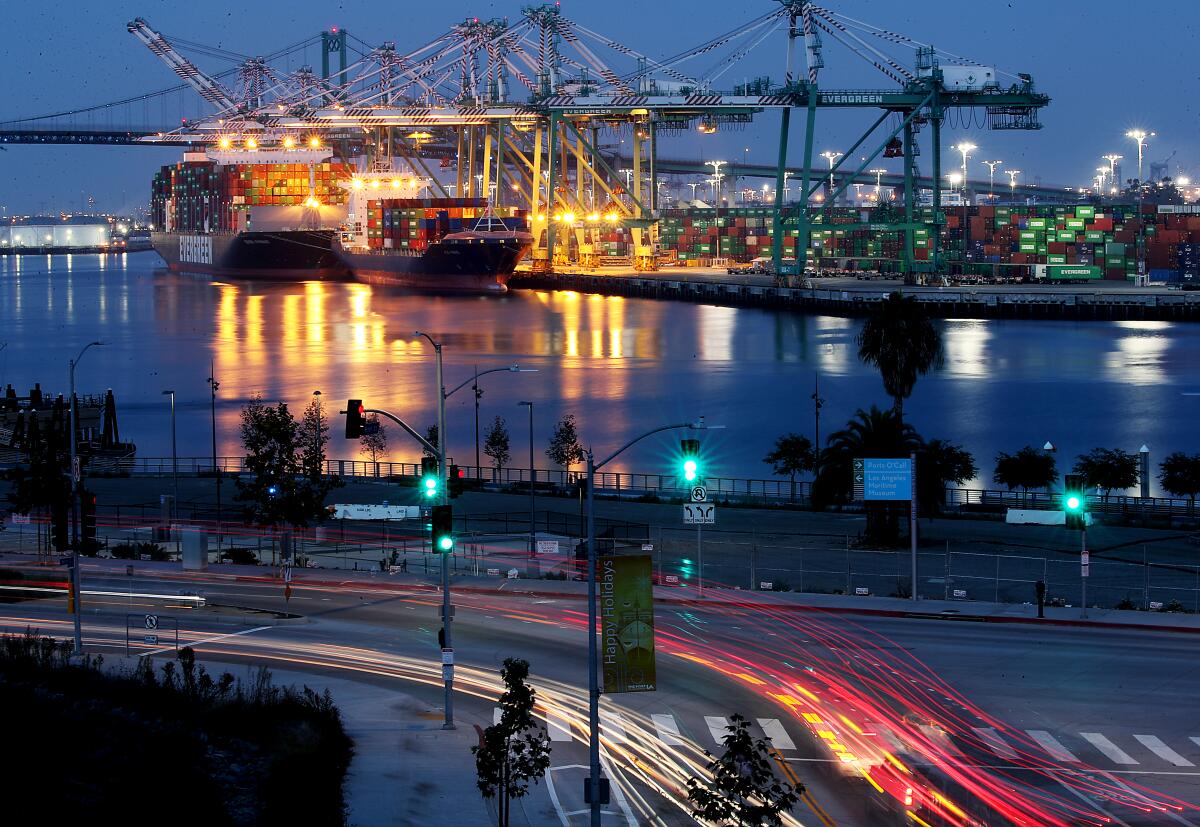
[{"left": 150, "top": 229, "right": 349, "bottom": 281}]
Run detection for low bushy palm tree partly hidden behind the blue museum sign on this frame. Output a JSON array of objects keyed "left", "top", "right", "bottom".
[{"left": 812, "top": 404, "right": 923, "bottom": 543}]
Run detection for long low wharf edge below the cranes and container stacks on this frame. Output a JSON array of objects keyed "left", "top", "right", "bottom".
[{"left": 509, "top": 268, "right": 1200, "bottom": 322}]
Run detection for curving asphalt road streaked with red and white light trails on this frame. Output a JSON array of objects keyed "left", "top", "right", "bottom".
[{"left": 0, "top": 563, "right": 1200, "bottom": 827}]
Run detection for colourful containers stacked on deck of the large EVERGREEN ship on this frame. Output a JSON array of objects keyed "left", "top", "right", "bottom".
[{"left": 150, "top": 161, "right": 350, "bottom": 233}]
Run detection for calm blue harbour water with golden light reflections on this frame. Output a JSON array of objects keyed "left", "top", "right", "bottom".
[{"left": 0, "top": 253, "right": 1200, "bottom": 494}]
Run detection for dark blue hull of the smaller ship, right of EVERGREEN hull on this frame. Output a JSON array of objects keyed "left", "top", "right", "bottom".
[{"left": 337, "top": 239, "right": 529, "bottom": 294}]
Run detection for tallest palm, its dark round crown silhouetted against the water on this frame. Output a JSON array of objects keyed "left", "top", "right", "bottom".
[{"left": 856, "top": 293, "right": 943, "bottom": 419}]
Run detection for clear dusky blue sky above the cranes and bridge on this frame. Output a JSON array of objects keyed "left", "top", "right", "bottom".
[{"left": 0, "top": 0, "right": 1200, "bottom": 214}]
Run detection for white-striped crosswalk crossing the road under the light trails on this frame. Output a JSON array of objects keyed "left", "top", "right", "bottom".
[{"left": 484, "top": 707, "right": 1200, "bottom": 775}]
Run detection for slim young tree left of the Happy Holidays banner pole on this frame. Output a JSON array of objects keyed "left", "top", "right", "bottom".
[{"left": 470, "top": 658, "right": 550, "bottom": 827}]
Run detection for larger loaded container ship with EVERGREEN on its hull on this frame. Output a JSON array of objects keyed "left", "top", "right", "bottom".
[{"left": 150, "top": 146, "right": 349, "bottom": 281}]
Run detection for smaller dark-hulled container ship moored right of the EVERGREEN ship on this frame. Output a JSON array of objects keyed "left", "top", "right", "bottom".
[{"left": 336, "top": 172, "right": 533, "bottom": 293}]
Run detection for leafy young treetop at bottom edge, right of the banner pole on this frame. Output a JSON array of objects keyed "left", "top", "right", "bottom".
[{"left": 688, "top": 715, "right": 804, "bottom": 827}]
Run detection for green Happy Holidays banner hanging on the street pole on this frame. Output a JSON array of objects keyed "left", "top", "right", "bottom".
[{"left": 599, "top": 555, "right": 658, "bottom": 694}]
